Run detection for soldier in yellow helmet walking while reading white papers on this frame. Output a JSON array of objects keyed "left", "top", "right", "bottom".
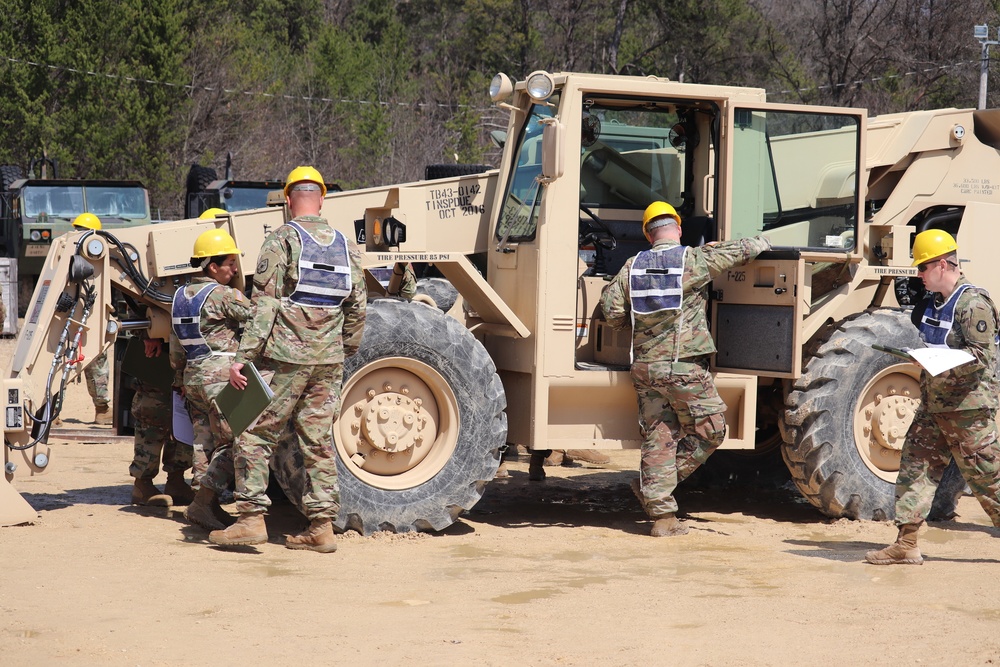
[{"left": 865, "top": 229, "right": 1000, "bottom": 565}]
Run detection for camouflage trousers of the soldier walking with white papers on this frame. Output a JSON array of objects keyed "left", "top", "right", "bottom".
[{"left": 896, "top": 408, "right": 1000, "bottom": 527}]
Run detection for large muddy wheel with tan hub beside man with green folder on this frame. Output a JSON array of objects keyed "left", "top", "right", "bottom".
[{"left": 334, "top": 299, "right": 507, "bottom": 535}]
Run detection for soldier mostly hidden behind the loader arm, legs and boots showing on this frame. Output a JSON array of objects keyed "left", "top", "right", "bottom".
[{"left": 128, "top": 338, "right": 194, "bottom": 507}]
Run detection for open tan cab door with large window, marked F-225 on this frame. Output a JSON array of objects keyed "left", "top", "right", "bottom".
[{"left": 712, "top": 103, "right": 866, "bottom": 378}]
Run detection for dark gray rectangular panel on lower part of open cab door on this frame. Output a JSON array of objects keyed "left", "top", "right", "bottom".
[{"left": 715, "top": 303, "right": 794, "bottom": 373}]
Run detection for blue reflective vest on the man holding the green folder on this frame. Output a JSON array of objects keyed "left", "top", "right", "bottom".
[{"left": 288, "top": 220, "right": 351, "bottom": 308}]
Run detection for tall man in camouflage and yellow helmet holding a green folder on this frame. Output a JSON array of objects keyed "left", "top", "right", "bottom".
[{"left": 209, "top": 167, "right": 367, "bottom": 553}]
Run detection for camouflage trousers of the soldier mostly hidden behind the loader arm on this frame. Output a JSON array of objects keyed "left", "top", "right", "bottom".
[{"left": 128, "top": 380, "right": 191, "bottom": 479}]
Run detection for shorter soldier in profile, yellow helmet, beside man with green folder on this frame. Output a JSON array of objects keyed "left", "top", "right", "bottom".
[{"left": 170, "top": 224, "right": 250, "bottom": 530}]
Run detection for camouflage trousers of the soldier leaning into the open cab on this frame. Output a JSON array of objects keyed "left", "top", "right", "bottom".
[{"left": 632, "top": 361, "right": 726, "bottom": 519}]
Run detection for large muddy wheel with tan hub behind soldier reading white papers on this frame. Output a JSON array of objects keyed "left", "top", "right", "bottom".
[{"left": 781, "top": 309, "right": 965, "bottom": 521}]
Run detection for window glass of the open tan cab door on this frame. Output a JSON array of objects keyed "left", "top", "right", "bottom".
[{"left": 731, "top": 109, "right": 859, "bottom": 251}]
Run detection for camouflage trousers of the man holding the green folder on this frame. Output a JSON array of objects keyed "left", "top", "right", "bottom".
[{"left": 234, "top": 357, "right": 343, "bottom": 520}]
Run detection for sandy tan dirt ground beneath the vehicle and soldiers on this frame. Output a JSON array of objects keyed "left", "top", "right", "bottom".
[{"left": 0, "top": 334, "right": 1000, "bottom": 667}]
